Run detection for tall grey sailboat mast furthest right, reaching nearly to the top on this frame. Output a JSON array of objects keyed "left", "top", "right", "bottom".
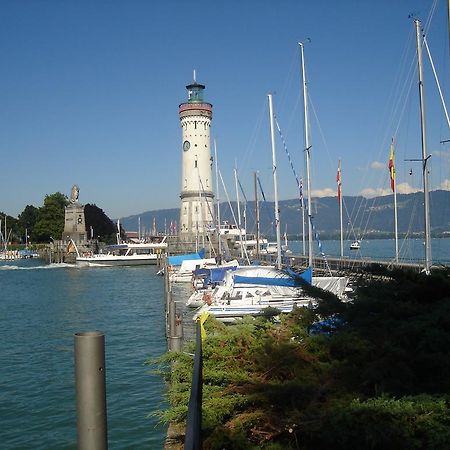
[{"left": 414, "top": 19, "right": 431, "bottom": 274}]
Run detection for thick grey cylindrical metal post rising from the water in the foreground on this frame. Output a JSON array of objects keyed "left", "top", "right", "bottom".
[{"left": 74, "top": 331, "right": 108, "bottom": 450}]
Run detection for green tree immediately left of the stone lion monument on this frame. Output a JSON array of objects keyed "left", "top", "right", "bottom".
[{"left": 32, "top": 192, "right": 68, "bottom": 242}]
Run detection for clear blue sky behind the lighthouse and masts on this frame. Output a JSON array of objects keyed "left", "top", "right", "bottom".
[{"left": 0, "top": 0, "right": 450, "bottom": 218}]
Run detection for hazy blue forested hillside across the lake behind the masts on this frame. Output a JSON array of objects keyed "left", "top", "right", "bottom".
[{"left": 121, "top": 191, "right": 450, "bottom": 239}]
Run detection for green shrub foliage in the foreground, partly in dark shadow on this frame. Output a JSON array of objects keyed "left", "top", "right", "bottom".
[{"left": 152, "top": 268, "right": 450, "bottom": 450}]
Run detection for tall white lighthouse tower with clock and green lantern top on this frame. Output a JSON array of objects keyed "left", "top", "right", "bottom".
[{"left": 179, "top": 76, "right": 214, "bottom": 240}]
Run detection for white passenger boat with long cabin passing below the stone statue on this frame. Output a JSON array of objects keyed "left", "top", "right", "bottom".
[{"left": 76, "top": 236, "right": 167, "bottom": 267}]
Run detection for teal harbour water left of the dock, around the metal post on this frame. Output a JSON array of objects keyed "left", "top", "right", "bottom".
[{"left": 0, "top": 260, "right": 166, "bottom": 450}]
